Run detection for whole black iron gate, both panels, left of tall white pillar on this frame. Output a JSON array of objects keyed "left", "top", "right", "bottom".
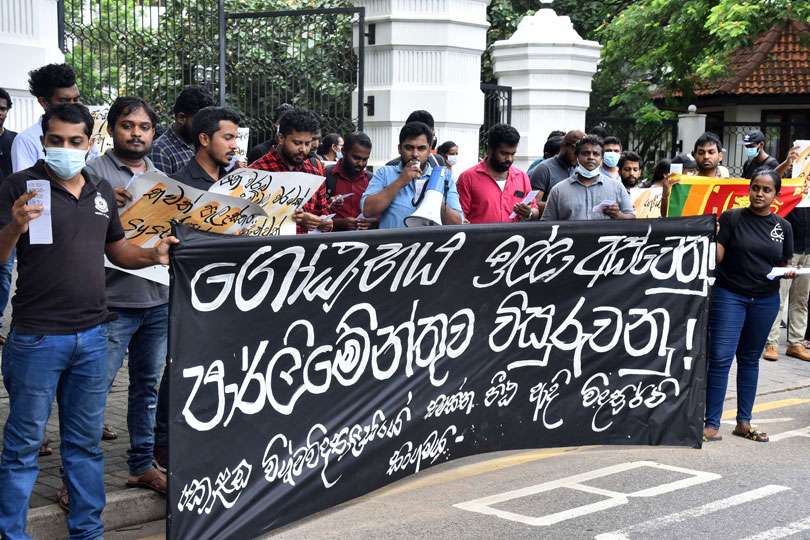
[{"left": 58, "top": 0, "right": 365, "bottom": 143}]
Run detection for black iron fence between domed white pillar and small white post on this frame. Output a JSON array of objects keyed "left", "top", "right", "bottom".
[{"left": 585, "top": 117, "right": 680, "bottom": 172}]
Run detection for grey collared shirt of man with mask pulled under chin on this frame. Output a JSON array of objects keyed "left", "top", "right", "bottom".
[{"left": 542, "top": 174, "right": 635, "bottom": 221}]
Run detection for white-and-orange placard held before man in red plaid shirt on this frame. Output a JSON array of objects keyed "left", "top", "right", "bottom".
[{"left": 209, "top": 169, "right": 324, "bottom": 236}]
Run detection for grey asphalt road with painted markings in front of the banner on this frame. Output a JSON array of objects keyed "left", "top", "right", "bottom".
[{"left": 108, "top": 359, "right": 810, "bottom": 540}]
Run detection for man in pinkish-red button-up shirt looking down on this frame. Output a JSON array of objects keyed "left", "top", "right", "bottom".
[{"left": 456, "top": 124, "right": 539, "bottom": 223}]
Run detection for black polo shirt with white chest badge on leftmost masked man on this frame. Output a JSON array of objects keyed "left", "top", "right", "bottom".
[{"left": 0, "top": 160, "right": 124, "bottom": 334}]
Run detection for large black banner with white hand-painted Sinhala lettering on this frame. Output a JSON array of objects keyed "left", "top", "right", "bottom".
[{"left": 169, "top": 216, "right": 715, "bottom": 539}]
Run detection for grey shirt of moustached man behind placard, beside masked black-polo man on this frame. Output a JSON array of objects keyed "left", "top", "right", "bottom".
[{"left": 87, "top": 149, "right": 169, "bottom": 309}]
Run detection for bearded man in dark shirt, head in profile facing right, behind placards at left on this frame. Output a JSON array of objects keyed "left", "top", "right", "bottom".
[{"left": 173, "top": 107, "right": 241, "bottom": 191}]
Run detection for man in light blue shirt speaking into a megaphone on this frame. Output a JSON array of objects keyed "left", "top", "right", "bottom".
[{"left": 360, "top": 122, "right": 463, "bottom": 229}]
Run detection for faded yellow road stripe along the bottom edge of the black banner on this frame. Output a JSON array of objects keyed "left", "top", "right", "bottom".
[{"left": 363, "top": 446, "right": 580, "bottom": 498}]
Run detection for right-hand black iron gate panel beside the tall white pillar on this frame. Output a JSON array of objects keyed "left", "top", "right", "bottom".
[{"left": 220, "top": 8, "right": 365, "bottom": 150}]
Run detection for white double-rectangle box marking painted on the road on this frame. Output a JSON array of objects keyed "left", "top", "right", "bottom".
[{"left": 453, "top": 461, "right": 721, "bottom": 527}]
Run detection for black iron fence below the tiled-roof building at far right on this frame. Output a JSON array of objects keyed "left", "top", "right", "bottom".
[{"left": 704, "top": 117, "right": 810, "bottom": 176}]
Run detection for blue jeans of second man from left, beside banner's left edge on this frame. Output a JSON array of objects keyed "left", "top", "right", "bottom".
[{"left": 107, "top": 304, "right": 169, "bottom": 476}]
